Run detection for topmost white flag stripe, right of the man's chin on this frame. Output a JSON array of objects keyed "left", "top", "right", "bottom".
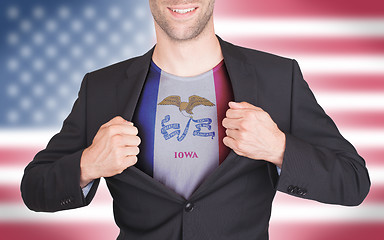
[{"left": 215, "top": 18, "right": 384, "bottom": 38}]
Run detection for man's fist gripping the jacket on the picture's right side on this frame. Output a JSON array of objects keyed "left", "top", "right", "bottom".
[{"left": 223, "top": 102, "right": 285, "bottom": 168}]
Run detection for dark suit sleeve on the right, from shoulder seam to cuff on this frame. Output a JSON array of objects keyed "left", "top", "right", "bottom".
[{"left": 277, "top": 60, "right": 370, "bottom": 206}]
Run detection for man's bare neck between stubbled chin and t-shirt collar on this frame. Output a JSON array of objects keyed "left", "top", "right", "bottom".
[{"left": 152, "top": 22, "right": 223, "bottom": 76}]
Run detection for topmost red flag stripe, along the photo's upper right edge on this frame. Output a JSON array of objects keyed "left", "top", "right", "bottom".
[{"left": 215, "top": 0, "right": 384, "bottom": 18}]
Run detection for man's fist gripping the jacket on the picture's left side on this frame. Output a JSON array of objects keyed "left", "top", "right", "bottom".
[{"left": 80, "top": 116, "right": 140, "bottom": 187}]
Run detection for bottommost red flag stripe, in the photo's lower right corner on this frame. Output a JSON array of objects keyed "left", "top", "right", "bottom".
[{"left": 269, "top": 222, "right": 384, "bottom": 240}]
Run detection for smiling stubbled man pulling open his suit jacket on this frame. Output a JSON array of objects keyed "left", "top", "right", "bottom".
[{"left": 21, "top": 0, "right": 370, "bottom": 240}]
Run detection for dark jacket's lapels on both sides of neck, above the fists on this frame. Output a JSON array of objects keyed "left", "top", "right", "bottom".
[{"left": 117, "top": 36, "right": 257, "bottom": 120}]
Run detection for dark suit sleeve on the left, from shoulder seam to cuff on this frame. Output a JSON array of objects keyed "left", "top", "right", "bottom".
[{"left": 21, "top": 75, "right": 99, "bottom": 212}]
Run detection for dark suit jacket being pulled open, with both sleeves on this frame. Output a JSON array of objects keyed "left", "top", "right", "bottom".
[{"left": 21, "top": 36, "right": 370, "bottom": 240}]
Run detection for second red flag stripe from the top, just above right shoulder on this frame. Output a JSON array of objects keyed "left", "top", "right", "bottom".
[{"left": 226, "top": 37, "right": 384, "bottom": 56}]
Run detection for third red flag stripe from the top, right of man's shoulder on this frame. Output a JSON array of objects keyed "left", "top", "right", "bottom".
[{"left": 304, "top": 73, "right": 384, "bottom": 92}]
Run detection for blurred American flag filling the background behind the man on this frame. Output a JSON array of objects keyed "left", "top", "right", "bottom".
[{"left": 0, "top": 0, "right": 384, "bottom": 240}]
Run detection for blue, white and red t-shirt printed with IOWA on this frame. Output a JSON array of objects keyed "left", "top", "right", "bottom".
[{"left": 133, "top": 61, "right": 233, "bottom": 199}]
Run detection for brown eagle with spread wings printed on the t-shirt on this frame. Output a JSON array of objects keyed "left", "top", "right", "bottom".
[{"left": 158, "top": 95, "right": 215, "bottom": 116}]
